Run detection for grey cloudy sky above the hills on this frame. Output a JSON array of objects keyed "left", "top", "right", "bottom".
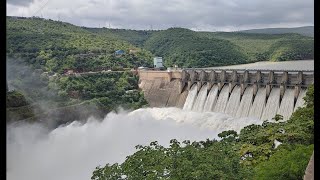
[{"left": 7, "top": 0, "right": 314, "bottom": 31}]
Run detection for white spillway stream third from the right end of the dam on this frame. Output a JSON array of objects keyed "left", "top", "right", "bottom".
[{"left": 261, "top": 87, "right": 280, "bottom": 121}]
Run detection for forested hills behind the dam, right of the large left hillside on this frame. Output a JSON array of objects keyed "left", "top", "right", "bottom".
[{"left": 88, "top": 28, "right": 314, "bottom": 67}]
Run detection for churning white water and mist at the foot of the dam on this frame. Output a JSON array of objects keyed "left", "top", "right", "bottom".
[{"left": 7, "top": 108, "right": 262, "bottom": 180}]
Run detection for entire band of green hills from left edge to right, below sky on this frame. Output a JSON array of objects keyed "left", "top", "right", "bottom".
[{"left": 7, "top": 17, "right": 314, "bottom": 73}]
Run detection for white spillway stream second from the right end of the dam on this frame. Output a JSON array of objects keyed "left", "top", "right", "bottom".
[{"left": 277, "top": 88, "right": 294, "bottom": 121}]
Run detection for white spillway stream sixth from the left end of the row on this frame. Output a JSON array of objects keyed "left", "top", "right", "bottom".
[{"left": 235, "top": 86, "right": 253, "bottom": 118}]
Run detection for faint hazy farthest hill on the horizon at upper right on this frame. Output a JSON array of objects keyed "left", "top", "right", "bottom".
[{"left": 239, "top": 26, "right": 314, "bottom": 37}]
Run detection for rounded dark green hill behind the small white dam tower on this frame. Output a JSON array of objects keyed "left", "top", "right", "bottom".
[{"left": 144, "top": 28, "right": 247, "bottom": 67}]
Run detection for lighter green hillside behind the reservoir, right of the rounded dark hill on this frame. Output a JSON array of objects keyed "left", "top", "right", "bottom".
[{"left": 199, "top": 32, "right": 314, "bottom": 62}]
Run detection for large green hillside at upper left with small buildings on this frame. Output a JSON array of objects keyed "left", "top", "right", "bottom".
[{"left": 7, "top": 17, "right": 152, "bottom": 72}]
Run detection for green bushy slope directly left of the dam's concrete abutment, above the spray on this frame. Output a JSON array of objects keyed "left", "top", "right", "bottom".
[{"left": 52, "top": 72, "right": 147, "bottom": 112}]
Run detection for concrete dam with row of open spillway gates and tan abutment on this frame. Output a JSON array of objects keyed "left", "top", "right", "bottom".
[{"left": 138, "top": 69, "right": 314, "bottom": 120}]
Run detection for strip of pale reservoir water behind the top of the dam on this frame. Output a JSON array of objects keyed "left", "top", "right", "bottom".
[{"left": 203, "top": 60, "right": 314, "bottom": 71}]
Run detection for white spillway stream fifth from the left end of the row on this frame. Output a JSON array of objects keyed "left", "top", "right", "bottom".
[{"left": 224, "top": 86, "right": 241, "bottom": 117}]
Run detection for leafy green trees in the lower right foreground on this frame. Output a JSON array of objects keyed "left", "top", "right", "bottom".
[{"left": 91, "top": 86, "right": 314, "bottom": 180}]
